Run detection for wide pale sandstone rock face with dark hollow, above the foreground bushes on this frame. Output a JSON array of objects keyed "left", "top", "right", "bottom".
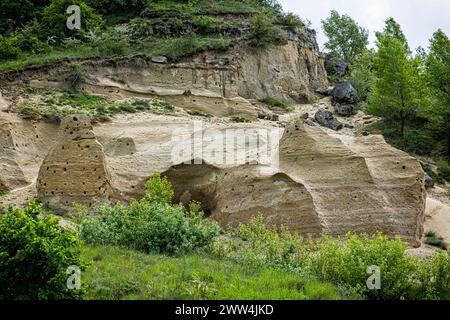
[{"left": 2, "top": 111, "right": 425, "bottom": 245}]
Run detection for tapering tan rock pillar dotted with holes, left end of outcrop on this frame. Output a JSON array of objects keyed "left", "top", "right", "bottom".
[{"left": 37, "top": 115, "right": 111, "bottom": 208}]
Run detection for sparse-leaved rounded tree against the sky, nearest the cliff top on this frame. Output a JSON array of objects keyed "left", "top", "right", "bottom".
[{"left": 322, "top": 10, "right": 369, "bottom": 63}]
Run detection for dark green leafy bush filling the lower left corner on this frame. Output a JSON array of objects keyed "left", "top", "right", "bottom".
[{"left": 0, "top": 202, "right": 84, "bottom": 300}]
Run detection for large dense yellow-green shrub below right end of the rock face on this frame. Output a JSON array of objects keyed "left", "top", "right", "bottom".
[{"left": 308, "top": 234, "right": 414, "bottom": 299}]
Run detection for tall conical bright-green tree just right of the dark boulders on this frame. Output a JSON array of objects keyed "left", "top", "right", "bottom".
[{"left": 366, "top": 18, "right": 420, "bottom": 136}]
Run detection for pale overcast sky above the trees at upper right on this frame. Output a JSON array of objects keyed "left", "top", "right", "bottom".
[{"left": 279, "top": 0, "right": 450, "bottom": 49}]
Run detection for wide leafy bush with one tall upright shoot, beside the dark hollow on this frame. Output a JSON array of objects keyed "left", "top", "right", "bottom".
[{"left": 81, "top": 173, "right": 223, "bottom": 254}]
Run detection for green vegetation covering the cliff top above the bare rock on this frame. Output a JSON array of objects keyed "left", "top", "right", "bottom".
[{"left": 0, "top": 0, "right": 305, "bottom": 72}]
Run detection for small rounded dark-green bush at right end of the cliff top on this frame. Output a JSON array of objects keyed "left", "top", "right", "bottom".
[{"left": 248, "top": 13, "right": 283, "bottom": 49}]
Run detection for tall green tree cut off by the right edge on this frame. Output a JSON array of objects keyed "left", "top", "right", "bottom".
[{"left": 425, "top": 29, "right": 450, "bottom": 158}]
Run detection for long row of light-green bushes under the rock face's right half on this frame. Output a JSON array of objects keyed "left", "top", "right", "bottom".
[{"left": 213, "top": 216, "right": 450, "bottom": 299}]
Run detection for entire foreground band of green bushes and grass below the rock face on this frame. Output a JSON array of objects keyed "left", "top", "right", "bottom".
[{"left": 0, "top": 173, "right": 450, "bottom": 299}]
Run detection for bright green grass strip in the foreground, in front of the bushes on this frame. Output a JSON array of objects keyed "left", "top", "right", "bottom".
[{"left": 82, "top": 246, "right": 352, "bottom": 300}]
